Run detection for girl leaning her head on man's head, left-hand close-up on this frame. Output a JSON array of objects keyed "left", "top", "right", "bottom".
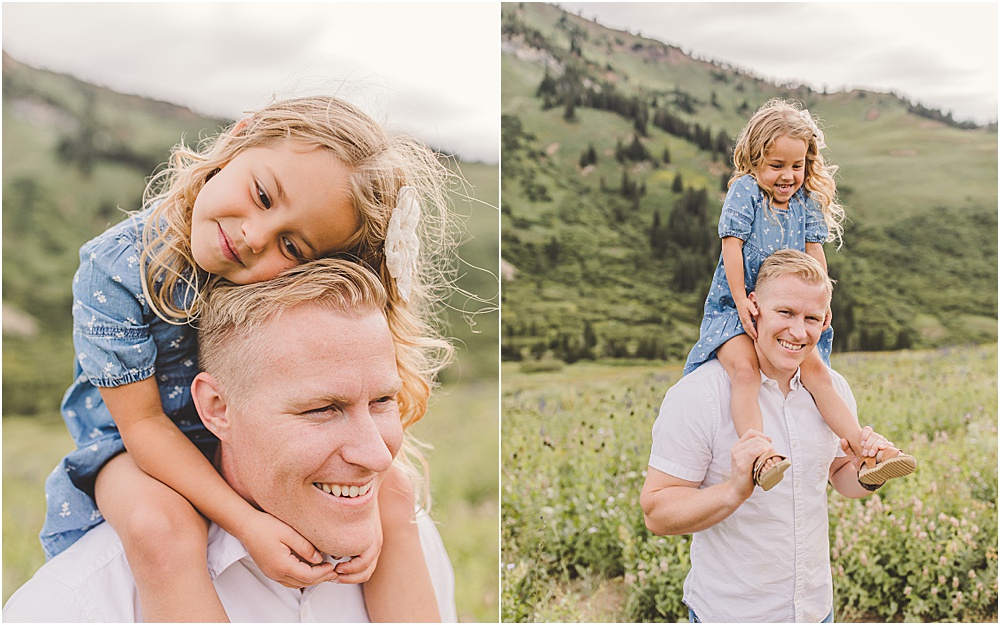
[{"left": 40, "top": 97, "right": 454, "bottom": 621}]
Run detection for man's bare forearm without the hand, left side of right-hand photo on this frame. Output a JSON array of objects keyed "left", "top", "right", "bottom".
[{"left": 640, "top": 482, "right": 745, "bottom": 536}]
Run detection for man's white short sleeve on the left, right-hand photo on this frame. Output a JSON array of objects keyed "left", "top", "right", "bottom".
[{"left": 649, "top": 376, "right": 719, "bottom": 483}]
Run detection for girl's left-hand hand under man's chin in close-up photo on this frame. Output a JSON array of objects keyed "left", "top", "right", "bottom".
[{"left": 237, "top": 511, "right": 337, "bottom": 588}]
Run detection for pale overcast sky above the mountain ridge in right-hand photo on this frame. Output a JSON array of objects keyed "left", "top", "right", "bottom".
[{"left": 559, "top": 2, "right": 997, "bottom": 122}]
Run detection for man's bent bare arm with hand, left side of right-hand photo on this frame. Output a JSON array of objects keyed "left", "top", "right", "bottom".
[{"left": 639, "top": 430, "right": 771, "bottom": 536}]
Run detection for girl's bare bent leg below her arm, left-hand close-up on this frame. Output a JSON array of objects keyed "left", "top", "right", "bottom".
[{"left": 94, "top": 453, "right": 229, "bottom": 622}]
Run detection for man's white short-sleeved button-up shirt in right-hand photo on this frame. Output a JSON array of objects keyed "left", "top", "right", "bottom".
[{"left": 649, "top": 360, "right": 857, "bottom": 623}]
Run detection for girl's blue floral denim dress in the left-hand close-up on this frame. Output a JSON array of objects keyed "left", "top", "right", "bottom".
[{"left": 39, "top": 209, "right": 215, "bottom": 558}]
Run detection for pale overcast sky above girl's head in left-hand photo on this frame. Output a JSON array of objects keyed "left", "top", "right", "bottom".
[{"left": 3, "top": 2, "right": 500, "bottom": 163}]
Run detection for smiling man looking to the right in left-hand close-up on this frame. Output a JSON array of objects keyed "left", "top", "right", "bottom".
[{"left": 3, "top": 260, "right": 456, "bottom": 622}]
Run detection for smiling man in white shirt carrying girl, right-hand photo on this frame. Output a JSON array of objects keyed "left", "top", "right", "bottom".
[{"left": 641, "top": 250, "right": 884, "bottom": 623}]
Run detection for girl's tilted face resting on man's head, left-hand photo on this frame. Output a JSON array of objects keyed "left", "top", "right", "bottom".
[{"left": 191, "top": 140, "right": 358, "bottom": 284}]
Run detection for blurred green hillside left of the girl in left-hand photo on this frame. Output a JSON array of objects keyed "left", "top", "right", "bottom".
[{"left": 3, "top": 53, "right": 232, "bottom": 415}]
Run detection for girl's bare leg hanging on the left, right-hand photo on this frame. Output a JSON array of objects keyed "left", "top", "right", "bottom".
[{"left": 716, "top": 334, "right": 781, "bottom": 484}]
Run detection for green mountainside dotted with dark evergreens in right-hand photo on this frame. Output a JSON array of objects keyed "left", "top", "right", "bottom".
[{"left": 501, "top": 3, "right": 997, "bottom": 362}]
